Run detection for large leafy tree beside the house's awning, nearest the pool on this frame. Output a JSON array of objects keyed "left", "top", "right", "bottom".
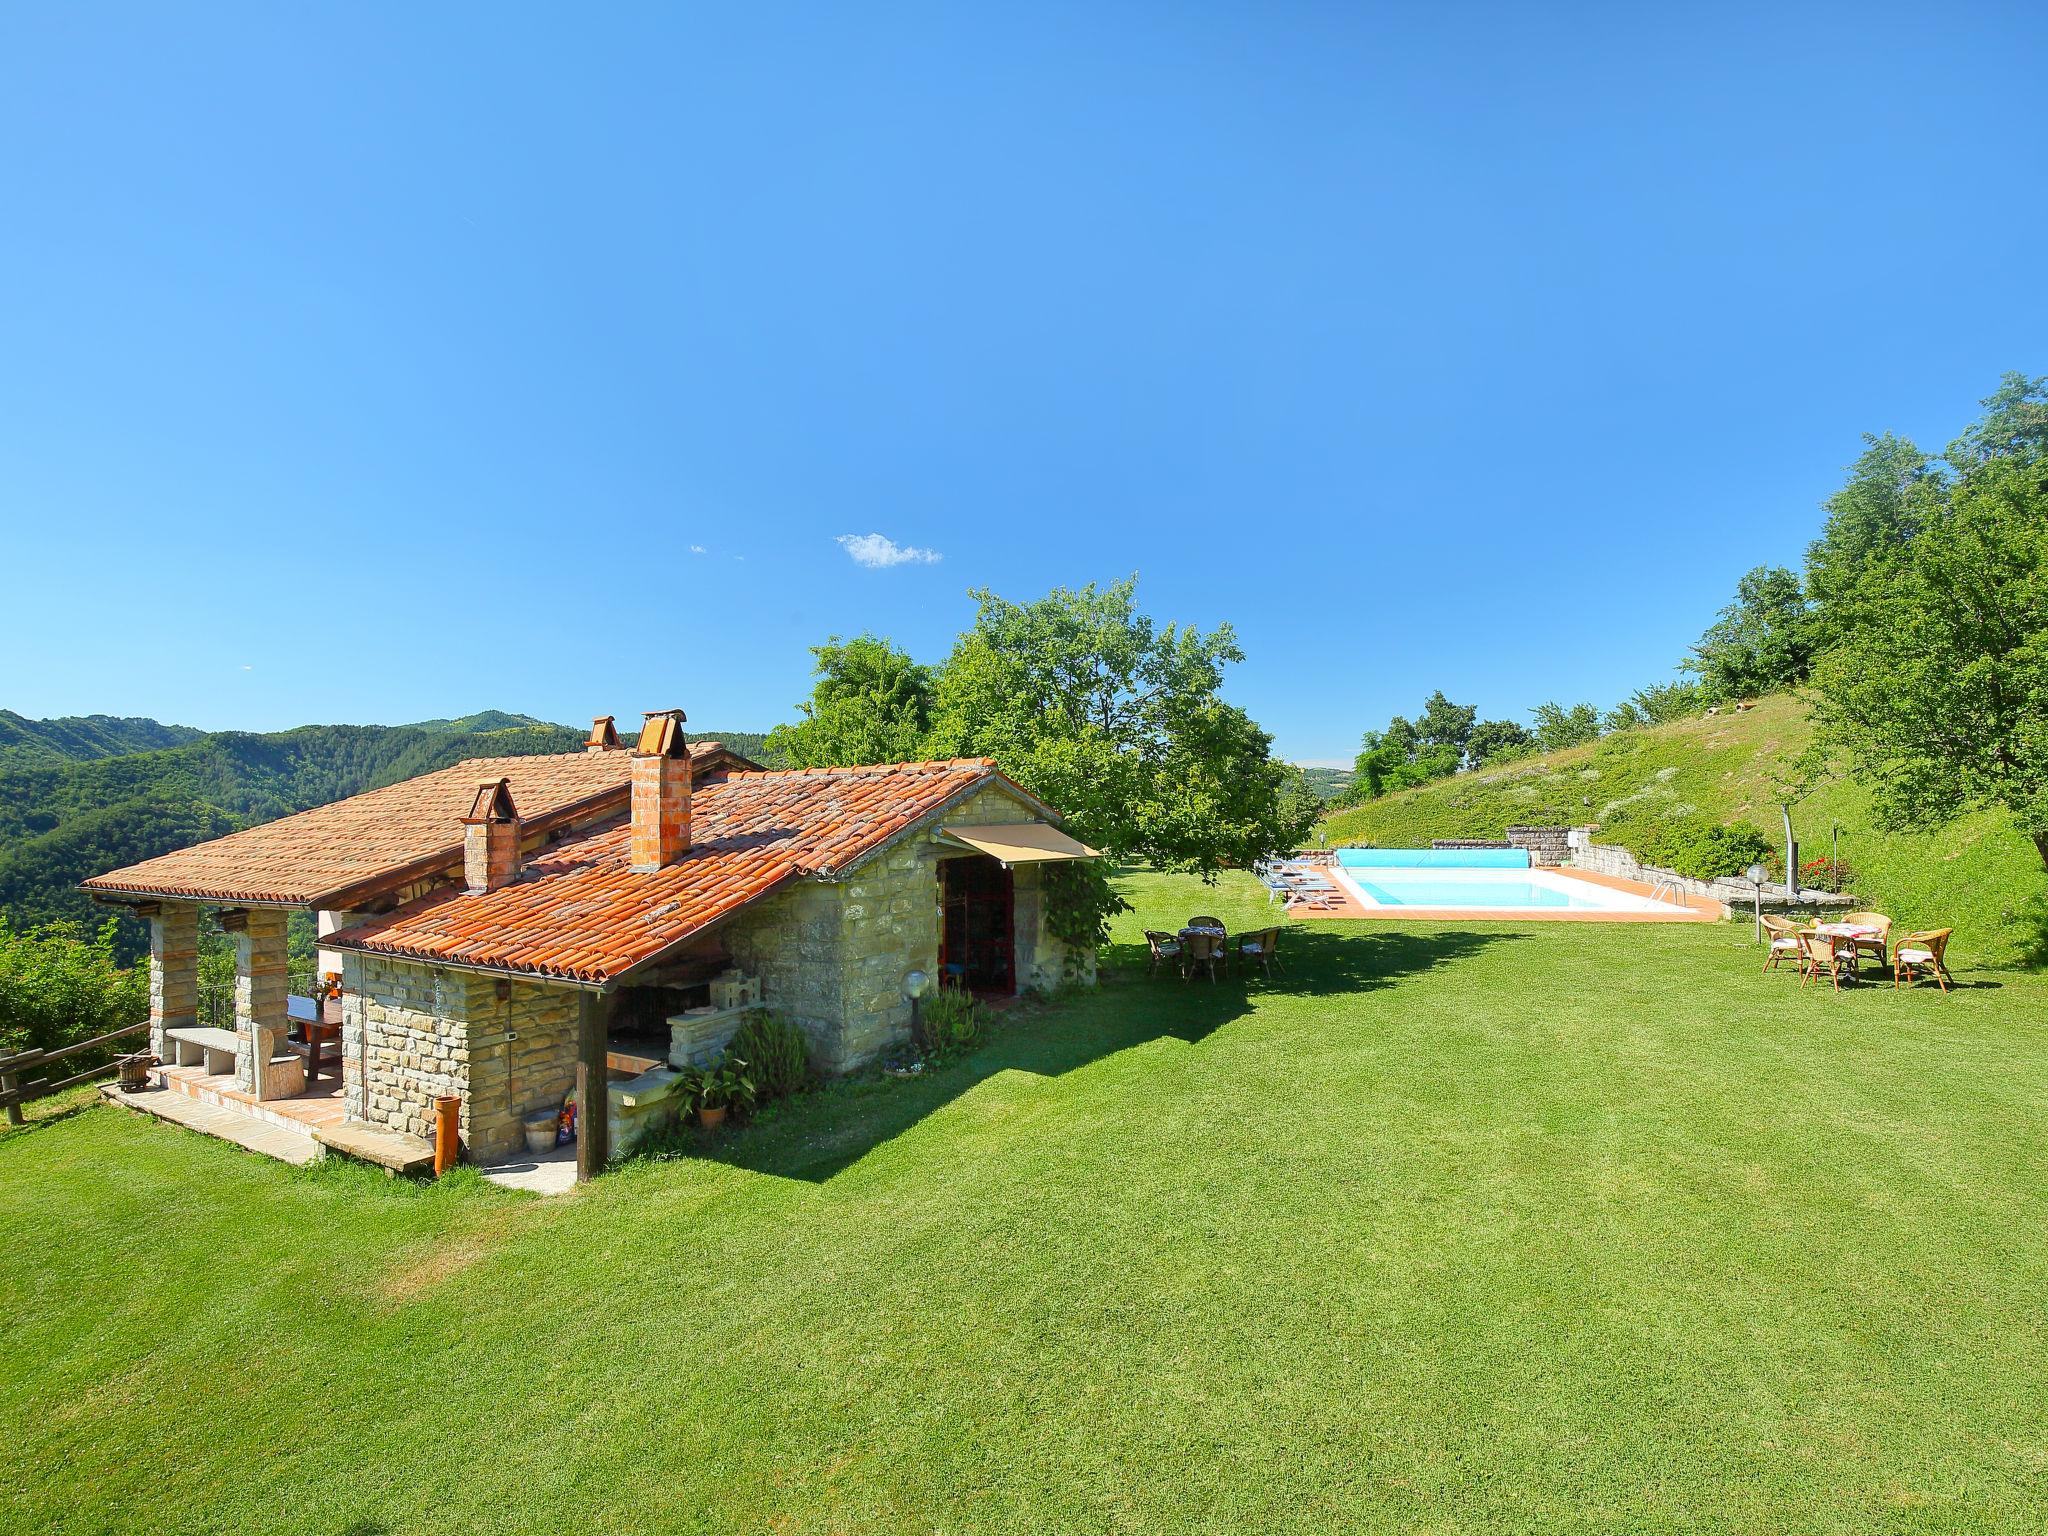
[{"left": 930, "top": 578, "right": 1317, "bottom": 872}]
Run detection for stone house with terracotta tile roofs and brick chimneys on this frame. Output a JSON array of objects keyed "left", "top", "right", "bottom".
[{"left": 84, "top": 711, "right": 1094, "bottom": 1165}]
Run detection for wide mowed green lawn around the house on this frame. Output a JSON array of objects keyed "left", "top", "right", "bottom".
[{"left": 0, "top": 877, "right": 2048, "bottom": 1532}]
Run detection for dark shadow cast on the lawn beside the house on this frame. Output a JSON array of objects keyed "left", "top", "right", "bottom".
[{"left": 698, "top": 928, "right": 1522, "bottom": 1182}]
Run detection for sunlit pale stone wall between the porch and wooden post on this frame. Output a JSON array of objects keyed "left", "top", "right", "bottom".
[{"left": 342, "top": 952, "right": 582, "bottom": 1159}]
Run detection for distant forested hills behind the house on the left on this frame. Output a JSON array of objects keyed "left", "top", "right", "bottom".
[{"left": 0, "top": 711, "right": 762, "bottom": 954}]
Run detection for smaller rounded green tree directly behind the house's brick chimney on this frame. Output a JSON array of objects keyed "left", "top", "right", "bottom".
[{"left": 768, "top": 635, "right": 934, "bottom": 768}]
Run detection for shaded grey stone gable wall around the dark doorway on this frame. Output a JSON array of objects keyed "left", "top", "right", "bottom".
[{"left": 725, "top": 788, "right": 1096, "bottom": 1073}]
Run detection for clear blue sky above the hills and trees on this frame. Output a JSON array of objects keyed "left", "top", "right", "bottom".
[{"left": 0, "top": 4, "right": 2048, "bottom": 760}]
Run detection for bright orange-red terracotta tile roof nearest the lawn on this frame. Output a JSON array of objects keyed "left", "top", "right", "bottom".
[{"left": 324, "top": 758, "right": 1015, "bottom": 983}]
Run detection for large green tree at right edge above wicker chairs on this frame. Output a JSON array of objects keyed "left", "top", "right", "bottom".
[{"left": 1817, "top": 455, "right": 2048, "bottom": 866}]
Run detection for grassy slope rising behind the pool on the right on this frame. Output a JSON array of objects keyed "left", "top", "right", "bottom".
[{"left": 1327, "top": 696, "right": 2048, "bottom": 965}]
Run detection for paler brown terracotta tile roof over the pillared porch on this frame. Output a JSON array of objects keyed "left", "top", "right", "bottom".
[{"left": 84, "top": 741, "right": 761, "bottom": 907}]
